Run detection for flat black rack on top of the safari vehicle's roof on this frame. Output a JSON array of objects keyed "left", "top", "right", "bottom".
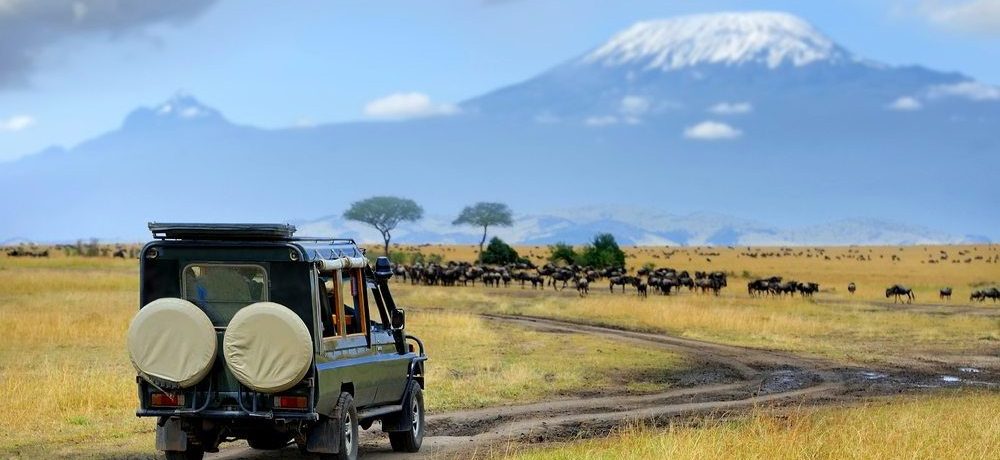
[{"left": 149, "top": 222, "right": 295, "bottom": 241}]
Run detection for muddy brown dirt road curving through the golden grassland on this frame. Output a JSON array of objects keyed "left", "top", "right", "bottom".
[{"left": 208, "top": 315, "right": 1000, "bottom": 459}]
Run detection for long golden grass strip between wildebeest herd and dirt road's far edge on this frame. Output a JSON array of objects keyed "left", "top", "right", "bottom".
[{"left": 396, "top": 284, "right": 1000, "bottom": 363}]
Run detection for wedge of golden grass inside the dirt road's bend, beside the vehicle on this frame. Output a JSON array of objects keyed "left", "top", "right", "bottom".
[{"left": 408, "top": 310, "right": 683, "bottom": 411}]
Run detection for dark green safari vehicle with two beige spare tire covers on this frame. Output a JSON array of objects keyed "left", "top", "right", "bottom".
[{"left": 127, "top": 223, "right": 427, "bottom": 459}]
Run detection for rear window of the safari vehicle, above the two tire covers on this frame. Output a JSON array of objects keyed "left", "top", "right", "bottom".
[{"left": 181, "top": 263, "right": 267, "bottom": 326}]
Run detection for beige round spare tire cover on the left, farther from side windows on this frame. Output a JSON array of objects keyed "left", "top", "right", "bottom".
[{"left": 126, "top": 297, "right": 218, "bottom": 388}]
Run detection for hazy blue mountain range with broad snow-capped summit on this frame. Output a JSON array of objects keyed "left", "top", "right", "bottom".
[{"left": 0, "top": 13, "right": 1000, "bottom": 244}]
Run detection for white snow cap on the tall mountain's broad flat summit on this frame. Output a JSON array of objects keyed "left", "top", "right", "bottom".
[{"left": 583, "top": 12, "right": 850, "bottom": 72}]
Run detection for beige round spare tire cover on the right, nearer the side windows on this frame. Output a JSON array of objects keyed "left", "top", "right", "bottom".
[{"left": 222, "top": 302, "right": 313, "bottom": 393}]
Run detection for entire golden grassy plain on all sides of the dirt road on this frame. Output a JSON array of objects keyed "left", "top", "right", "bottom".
[{"left": 0, "top": 245, "right": 1000, "bottom": 458}]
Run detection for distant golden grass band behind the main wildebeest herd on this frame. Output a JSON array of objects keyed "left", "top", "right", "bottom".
[{"left": 369, "top": 244, "right": 1000, "bottom": 303}]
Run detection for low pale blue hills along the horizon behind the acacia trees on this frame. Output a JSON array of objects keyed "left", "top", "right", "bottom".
[{"left": 295, "top": 207, "right": 989, "bottom": 246}]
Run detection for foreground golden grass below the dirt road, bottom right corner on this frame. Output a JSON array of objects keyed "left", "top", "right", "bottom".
[{"left": 508, "top": 392, "right": 1000, "bottom": 460}]
